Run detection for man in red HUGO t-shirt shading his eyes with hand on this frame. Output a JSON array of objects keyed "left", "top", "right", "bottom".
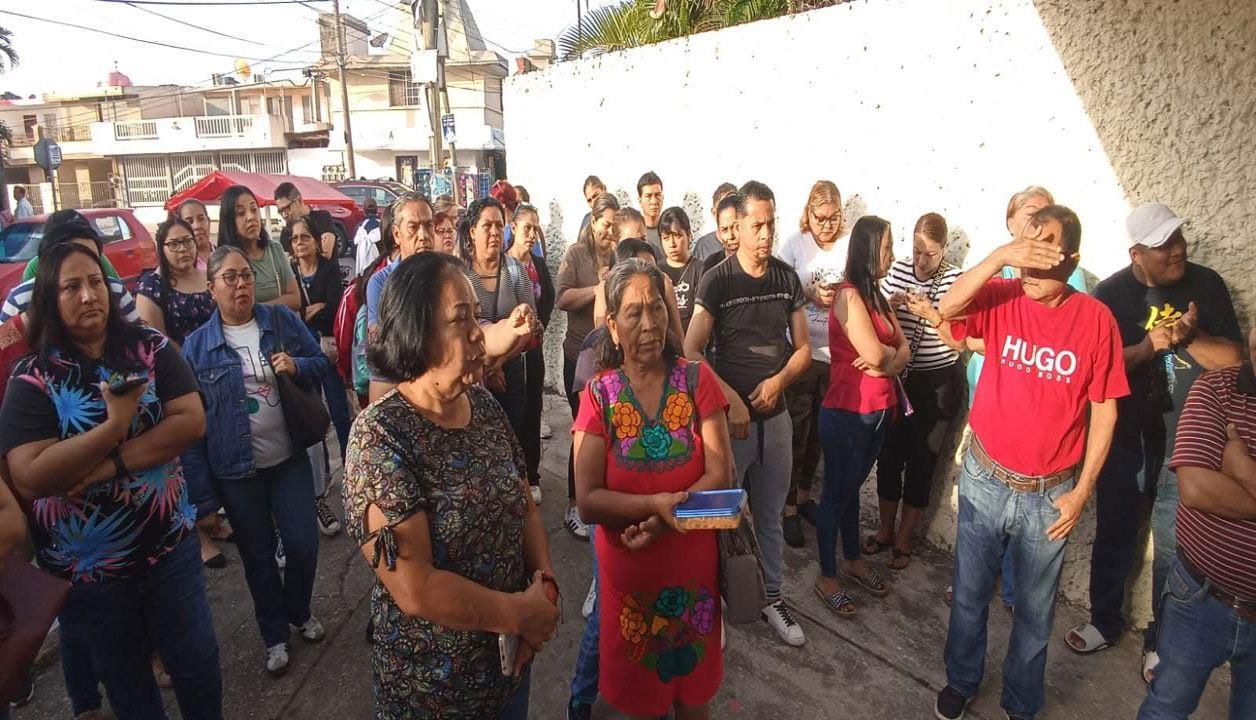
[{"left": 934, "top": 205, "right": 1129, "bottom": 720}]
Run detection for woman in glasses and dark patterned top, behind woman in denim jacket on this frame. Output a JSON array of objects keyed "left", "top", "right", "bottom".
[{"left": 136, "top": 217, "right": 232, "bottom": 568}]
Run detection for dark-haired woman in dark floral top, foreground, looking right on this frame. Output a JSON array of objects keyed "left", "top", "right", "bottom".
[{"left": 344, "top": 253, "right": 559, "bottom": 720}]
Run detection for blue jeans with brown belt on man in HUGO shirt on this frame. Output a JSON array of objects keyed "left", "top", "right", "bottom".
[{"left": 946, "top": 450, "right": 1075, "bottom": 717}]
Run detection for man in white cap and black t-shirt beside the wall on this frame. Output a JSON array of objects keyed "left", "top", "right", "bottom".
[{"left": 1065, "top": 202, "right": 1242, "bottom": 682}]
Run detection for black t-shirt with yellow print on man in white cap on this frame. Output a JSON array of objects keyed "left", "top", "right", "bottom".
[{"left": 1094, "top": 263, "right": 1242, "bottom": 455}]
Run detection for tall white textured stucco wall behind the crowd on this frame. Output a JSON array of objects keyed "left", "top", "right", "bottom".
[{"left": 505, "top": 0, "right": 1256, "bottom": 619}]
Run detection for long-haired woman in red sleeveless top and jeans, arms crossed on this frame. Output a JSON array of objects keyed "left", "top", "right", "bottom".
[{"left": 815, "top": 216, "right": 909, "bottom": 617}]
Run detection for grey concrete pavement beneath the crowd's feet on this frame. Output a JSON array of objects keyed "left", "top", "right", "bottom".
[{"left": 14, "top": 397, "right": 1230, "bottom": 720}]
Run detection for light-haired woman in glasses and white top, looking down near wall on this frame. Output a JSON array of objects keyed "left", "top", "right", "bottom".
[{"left": 777, "top": 180, "right": 850, "bottom": 548}]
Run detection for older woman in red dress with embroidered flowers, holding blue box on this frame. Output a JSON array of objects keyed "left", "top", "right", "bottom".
[{"left": 571, "top": 260, "right": 731, "bottom": 720}]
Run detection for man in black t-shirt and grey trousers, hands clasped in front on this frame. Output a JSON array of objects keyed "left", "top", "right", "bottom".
[{"left": 685, "top": 181, "right": 811, "bottom": 646}]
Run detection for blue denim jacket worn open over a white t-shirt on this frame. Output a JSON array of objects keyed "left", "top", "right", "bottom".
[{"left": 183, "top": 304, "right": 330, "bottom": 481}]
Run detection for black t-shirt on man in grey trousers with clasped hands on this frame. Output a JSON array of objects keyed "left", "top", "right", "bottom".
[{"left": 696, "top": 255, "right": 806, "bottom": 420}]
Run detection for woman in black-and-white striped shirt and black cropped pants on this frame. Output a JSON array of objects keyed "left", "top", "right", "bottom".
[{"left": 863, "top": 212, "right": 965, "bottom": 570}]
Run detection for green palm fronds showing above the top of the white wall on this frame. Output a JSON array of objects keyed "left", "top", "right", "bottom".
[{"left": 558, "top": 0, "right": 845, "bottom": 59}]
